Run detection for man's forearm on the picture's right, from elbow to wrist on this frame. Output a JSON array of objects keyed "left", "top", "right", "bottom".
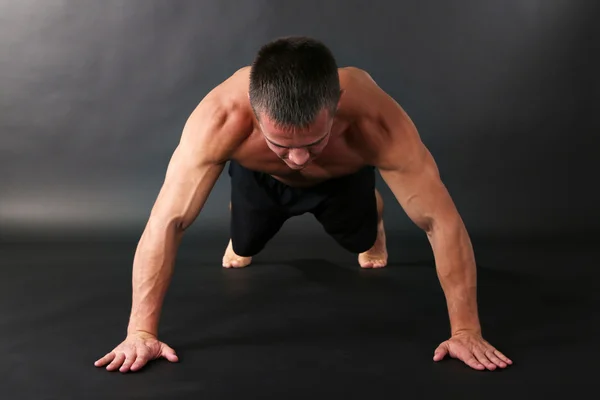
[{"left": 428, "top": 216, "right": 481, "bottom": 334}]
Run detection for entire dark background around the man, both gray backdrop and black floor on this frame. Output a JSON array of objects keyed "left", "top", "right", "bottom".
[{"left": 0, "top": 0, "right": 600, "bottom": 400}]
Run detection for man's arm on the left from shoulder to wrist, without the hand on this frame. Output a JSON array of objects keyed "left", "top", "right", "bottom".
[{"left": 127, "top": 98, "right": 244, "bottom": 336}]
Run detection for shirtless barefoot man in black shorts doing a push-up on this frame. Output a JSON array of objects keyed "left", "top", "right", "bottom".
[{"left": 95, "top": 37, "right": 512, "bottom": 372}]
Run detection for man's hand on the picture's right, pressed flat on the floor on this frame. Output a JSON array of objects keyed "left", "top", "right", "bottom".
[{"left": 433, "top": 332, "right": 512, "bottom": 371}]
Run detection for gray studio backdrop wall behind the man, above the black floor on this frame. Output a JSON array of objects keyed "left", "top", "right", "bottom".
[{"left": 0, "top": 0, "right": 600, "bottom": 238}]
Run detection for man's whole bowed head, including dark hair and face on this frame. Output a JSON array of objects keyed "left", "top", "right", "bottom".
[{"left": 249, "top": 37, "right": 340, "bottom": 169}]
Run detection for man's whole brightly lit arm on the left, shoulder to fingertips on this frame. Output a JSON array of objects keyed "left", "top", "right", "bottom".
[{"left": 94, "top": 71, "right": 251, "bottom": 372}]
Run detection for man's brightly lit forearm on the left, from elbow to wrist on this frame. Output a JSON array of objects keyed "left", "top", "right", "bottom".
[{"left": 127, "top": 219, "right": 181, "bottom": 335}]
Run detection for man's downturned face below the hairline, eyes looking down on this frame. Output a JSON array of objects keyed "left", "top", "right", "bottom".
[{"left": 260, "top": 110, "right": 333, "bottom": 170}]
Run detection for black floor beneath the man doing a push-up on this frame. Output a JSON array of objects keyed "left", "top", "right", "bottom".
[{"left": 0, "top": 230, "right": 600, "bottom": 400}]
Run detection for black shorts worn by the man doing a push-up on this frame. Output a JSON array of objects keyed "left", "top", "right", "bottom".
[{"left": 229, "top": 161, "right": 378, "bottom": 257}]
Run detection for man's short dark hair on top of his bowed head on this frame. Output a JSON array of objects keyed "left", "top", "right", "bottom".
[{"left": 249, "top": 36, "right": 340, "bottom": 127}]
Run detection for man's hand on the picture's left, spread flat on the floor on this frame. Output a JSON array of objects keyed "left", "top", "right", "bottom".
[{"left": 94, "top": 332, "right": 179, "bottom": 372}]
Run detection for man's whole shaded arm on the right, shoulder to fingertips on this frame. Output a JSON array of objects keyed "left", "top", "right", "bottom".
[{"left": 376, "top": 106, "right": 512, "bottom": 370}]
